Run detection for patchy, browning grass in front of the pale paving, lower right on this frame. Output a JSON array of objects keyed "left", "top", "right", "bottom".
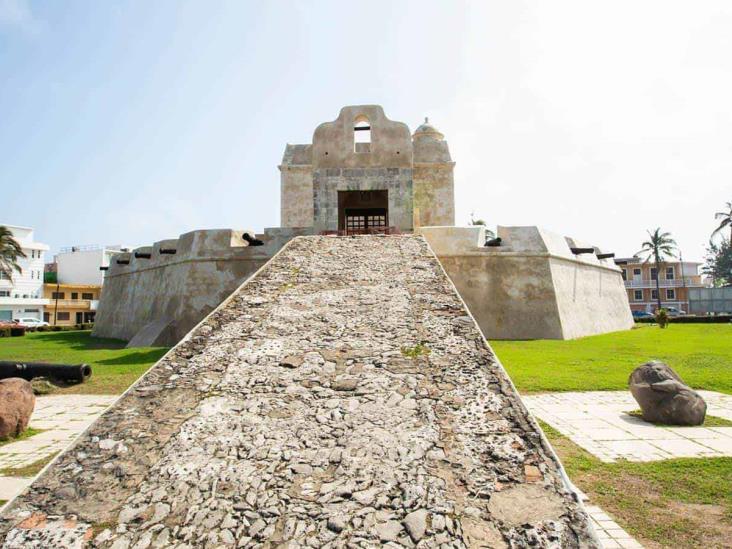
[{"left": 540, "top": 422, "right": 732, "bottom": 548}]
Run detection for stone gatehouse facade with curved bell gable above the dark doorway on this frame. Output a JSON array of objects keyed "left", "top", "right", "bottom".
[{"left": 279, "top": 105, "right": 455, "bottom": 231}]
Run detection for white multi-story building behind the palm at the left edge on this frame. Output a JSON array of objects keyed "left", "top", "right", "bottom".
[{"left": 0, "top": 225, "right": 48, "bottom": 321}]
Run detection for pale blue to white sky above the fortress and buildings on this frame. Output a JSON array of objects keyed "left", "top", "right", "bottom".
[{"left": 0, "top": 0, "right": 732, "bottom": 260}]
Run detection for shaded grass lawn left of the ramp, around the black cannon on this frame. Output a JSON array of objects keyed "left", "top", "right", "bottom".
[{"left": 0, "top": 331, "right": 167, "bottom": 394}]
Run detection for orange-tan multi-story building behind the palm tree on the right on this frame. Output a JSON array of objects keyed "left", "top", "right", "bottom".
[{"left": 615, "top": 256, "right": 704, "bottom": 312}]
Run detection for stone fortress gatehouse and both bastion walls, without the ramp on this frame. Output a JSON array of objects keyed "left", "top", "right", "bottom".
[{"left": 94, "top": 105, "right": 633, "bottom": 346}]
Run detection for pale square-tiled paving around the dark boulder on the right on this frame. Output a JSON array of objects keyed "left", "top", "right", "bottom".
[{"left": 523, "top": 391, "right": 732, "bottom": 462}]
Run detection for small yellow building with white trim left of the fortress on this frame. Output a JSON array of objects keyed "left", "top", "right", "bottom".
[{"left": 43, "top": 283, "right": 102, "bottom": 326}]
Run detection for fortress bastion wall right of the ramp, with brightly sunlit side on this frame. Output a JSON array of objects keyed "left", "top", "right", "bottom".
[{"left": 419, "top": 227, "right": 633, "bottom": 339}]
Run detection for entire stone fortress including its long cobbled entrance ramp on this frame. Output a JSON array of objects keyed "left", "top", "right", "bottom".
[{"left": 0, "top": 106, "right": 630, "bottom": 549}]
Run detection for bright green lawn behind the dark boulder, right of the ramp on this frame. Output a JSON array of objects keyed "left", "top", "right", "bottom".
[{"left": 491, "top": 324, "right": 732, "bottom": 394}]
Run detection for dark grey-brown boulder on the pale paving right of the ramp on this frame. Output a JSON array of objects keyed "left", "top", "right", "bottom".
[{"left": 628, "top": 360, "right": 707, "bottom": 425}]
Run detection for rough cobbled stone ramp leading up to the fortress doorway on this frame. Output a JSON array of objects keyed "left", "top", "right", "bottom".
[{"left": 0, "top": 236, "right": 597, "bottom": 549}]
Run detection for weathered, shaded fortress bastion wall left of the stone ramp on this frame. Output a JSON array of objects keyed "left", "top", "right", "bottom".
[{"left": 94, "top": 229, "right": 309, "bottom": 346}]
